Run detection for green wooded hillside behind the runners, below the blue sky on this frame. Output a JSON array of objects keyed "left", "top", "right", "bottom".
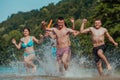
[{"left": 0, "top": 0, "right": 120, "bottom": 64}]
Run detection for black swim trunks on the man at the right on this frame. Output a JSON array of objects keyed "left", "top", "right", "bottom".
[{"left": 93, "top": 45, "right": 106, "bottom": 63}]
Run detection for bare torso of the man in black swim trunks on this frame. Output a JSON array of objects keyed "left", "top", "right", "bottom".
[{"left": 91, "top": 27, "right": 106, "bottom": 47}]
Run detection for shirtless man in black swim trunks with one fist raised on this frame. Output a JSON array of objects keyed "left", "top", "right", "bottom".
[{"left": 80, "top": 19, "right": 118, "bottom": 76}]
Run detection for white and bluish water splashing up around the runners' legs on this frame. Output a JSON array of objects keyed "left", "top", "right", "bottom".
[{"left": 0, "top": 39, "right": 120, "bottom": 77}]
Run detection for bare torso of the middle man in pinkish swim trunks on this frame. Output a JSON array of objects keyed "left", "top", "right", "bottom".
[{"left": 54, "top": 27, "right": 70, "bottom": 48}]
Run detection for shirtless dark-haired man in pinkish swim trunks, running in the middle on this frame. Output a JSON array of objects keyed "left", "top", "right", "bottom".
[{"left": 46, "top": 17, "right": 79, "bottom": 72}]
